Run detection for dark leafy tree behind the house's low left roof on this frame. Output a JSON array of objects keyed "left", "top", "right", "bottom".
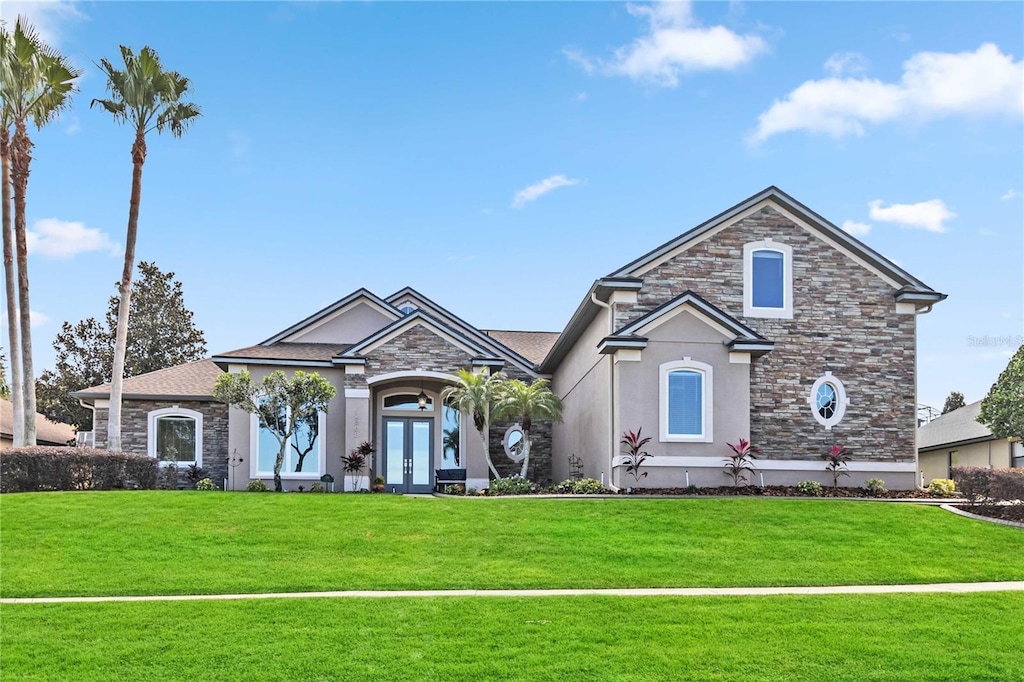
[{"left": 36, "top": 261, "right": 206, "bottom": 430}]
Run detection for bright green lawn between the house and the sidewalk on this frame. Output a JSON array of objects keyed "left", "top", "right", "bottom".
[{"left": 0, "top": 492, "right": 1024, "bottom": 593}]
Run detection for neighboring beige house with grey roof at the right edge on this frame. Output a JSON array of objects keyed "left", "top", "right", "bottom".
[{"left": 918, "top": 400, "right": 1024, "bottom": 485}]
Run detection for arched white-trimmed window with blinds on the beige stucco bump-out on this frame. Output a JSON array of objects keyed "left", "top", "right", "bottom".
[{"left": 659, "top": 357, "right": 714, "bottom": 442}]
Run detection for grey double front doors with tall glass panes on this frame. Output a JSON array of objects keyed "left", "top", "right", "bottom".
[{"left": 384, "top": 417, "right": 434, "bottom": 493}]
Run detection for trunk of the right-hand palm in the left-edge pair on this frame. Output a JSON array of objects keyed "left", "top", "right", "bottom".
[{"left": 10, "top": 121, "right": 36, "bottom": 446}]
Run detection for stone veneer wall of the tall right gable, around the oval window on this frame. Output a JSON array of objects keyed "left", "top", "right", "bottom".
[{"left": 615, "top": 202, "right": 916, "bottom": 462}]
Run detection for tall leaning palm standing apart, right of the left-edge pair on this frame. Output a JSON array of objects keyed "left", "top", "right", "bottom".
[{"left": 90, "top": 45, "right": 200, "bottom": 450}]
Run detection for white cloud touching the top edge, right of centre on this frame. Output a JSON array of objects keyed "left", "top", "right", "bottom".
[{"left": 562, "top": 2, "right": 768, "bottom": 88}]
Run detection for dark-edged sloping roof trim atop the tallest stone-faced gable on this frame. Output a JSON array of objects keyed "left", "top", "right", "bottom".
[{"left": 608, "top": 185, "right": 945, "bottom": 301}]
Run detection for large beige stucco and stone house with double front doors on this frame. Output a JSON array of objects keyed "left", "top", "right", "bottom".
[{"left": 74, "top": 187, "right": 945, "bottom": 492}]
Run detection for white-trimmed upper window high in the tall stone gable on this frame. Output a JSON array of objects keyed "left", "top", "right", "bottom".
[{"left": 743, "top": 239, "right": 793, "bottom": 318}]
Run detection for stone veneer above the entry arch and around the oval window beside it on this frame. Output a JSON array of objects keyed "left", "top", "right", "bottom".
[{"left": 345, "top": 327, "right": 551, "bottom": 482}]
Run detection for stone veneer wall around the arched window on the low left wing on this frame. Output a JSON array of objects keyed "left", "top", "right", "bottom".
[{"left": 93, "top": 400, "right": 228, "bottom": 486}]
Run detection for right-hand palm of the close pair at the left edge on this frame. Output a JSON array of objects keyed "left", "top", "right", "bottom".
[{"left": 0, "top": 16, "right": 82, "bottom": 445}]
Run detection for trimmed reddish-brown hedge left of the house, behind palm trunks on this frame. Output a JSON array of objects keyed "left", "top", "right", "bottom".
[{"left": 0, "top": 446, "right": 160, "bottom": 493}]
